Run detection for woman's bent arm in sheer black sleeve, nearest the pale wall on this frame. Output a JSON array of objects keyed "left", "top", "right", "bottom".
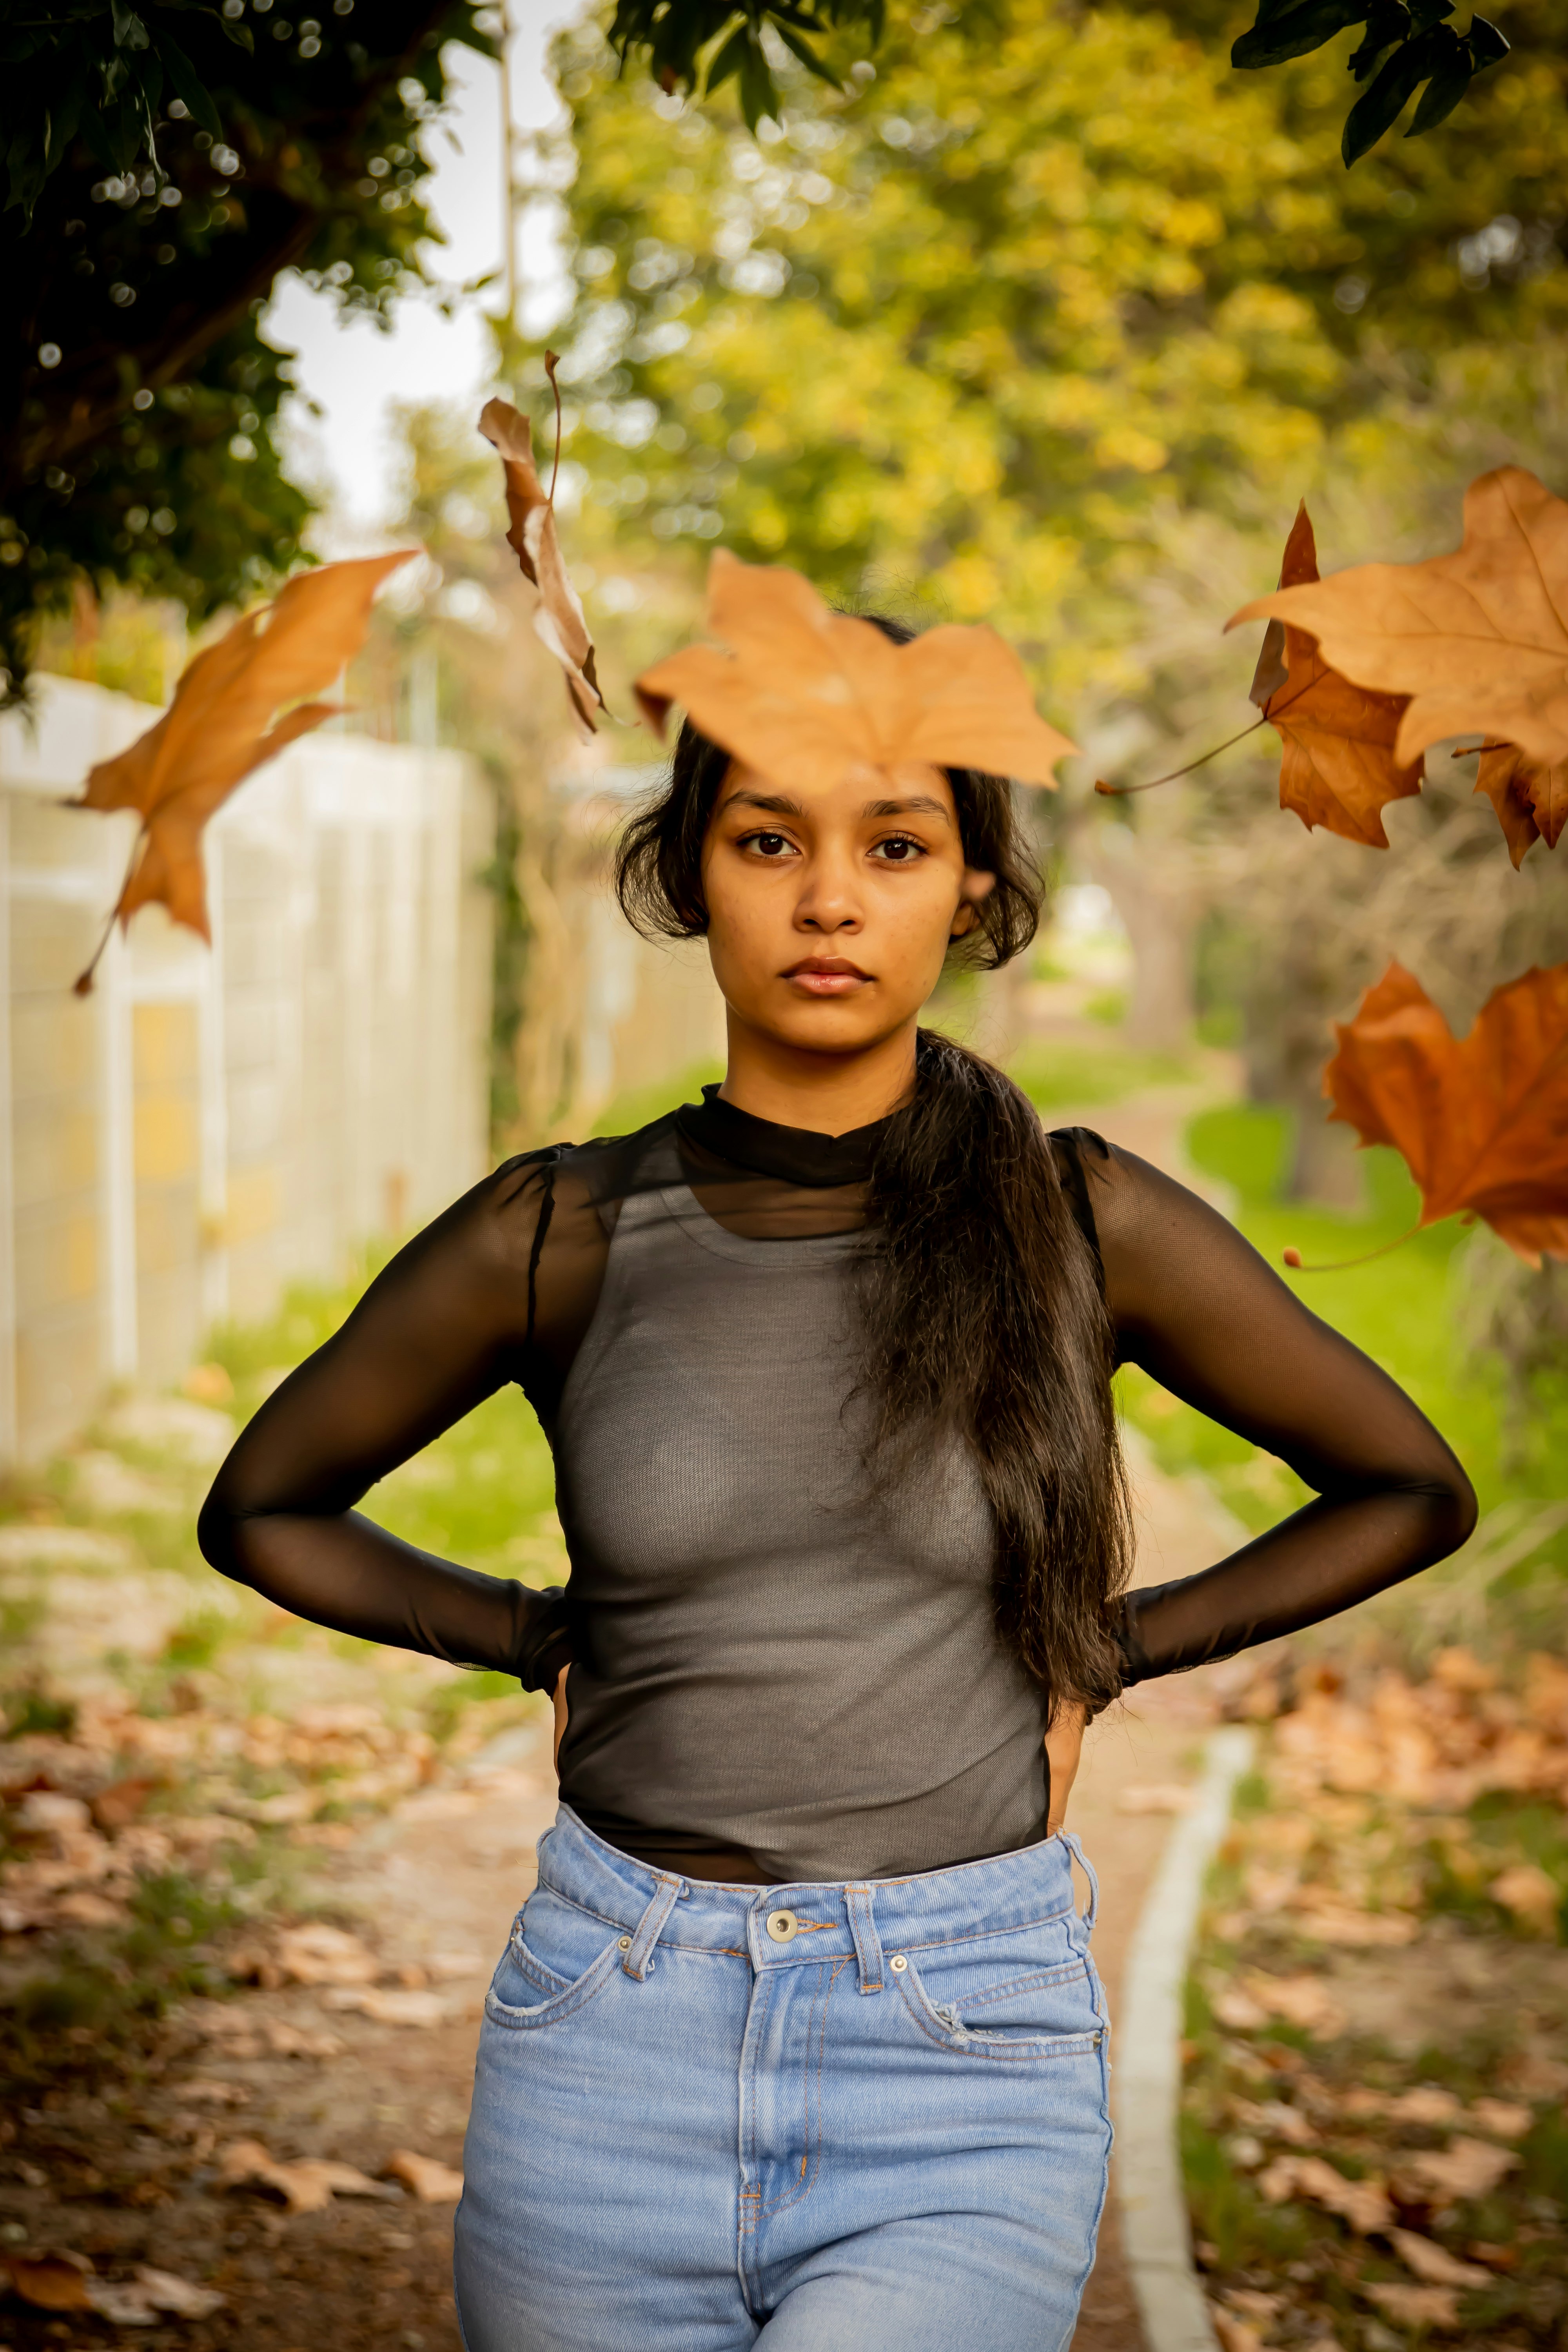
[{"left": 198, "top": 1157, "right": 569, "bottom": 1689}]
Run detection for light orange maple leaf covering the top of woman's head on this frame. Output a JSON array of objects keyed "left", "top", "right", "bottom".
[{"left": 637, "top": 548, "right": 1077, "bottom": 790}]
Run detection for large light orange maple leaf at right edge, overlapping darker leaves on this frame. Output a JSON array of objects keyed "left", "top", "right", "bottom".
[{"left": 1227, "top": 466, "right": 1568, "bottom": 767}]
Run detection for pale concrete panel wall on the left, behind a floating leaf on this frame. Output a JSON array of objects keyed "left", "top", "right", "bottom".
[{"left": 0, "top": 677, "right": 491, "bottom": 1461}]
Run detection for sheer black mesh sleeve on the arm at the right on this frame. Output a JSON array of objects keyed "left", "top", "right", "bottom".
[{"left": 1074, "top": 1129, "right": 1476, "bottom": 1682}]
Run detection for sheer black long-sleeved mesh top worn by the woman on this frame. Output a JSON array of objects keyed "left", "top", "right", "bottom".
[{"left": 200, "top": 1089, "right": 1474, "bottom": 1882}]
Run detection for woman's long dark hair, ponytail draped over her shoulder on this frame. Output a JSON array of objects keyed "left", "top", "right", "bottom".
[{"left": 616, "top": 614, "right": 1131, "bottom": 1712}]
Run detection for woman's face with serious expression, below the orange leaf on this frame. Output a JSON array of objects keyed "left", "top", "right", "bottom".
[{"left": 703, "top": 762, "right": 992, "bottom": 1054}]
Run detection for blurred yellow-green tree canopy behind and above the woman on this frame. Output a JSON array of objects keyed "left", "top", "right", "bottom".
[{"left": 536, "top": 0, "right": 1568, "bottom": 689}]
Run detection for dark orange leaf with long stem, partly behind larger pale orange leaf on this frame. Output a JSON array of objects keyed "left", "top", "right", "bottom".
[{"left": 1250, "top": 503, "right": 1422, "bottom": 849}]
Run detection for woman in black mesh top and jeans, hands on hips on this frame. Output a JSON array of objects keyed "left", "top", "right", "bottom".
[{"left": 202, "top": 588, "right": 1474, "bottom": 2352}]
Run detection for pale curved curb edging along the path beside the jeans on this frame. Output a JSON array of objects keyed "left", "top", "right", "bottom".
[{"left": 1112, "top": 1724, "right": 1255, "bottom": 2352}]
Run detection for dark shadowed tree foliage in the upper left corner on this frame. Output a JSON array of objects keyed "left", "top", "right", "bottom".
[{"left": 0, "top": 0, "right": 496, "bottom": 694}]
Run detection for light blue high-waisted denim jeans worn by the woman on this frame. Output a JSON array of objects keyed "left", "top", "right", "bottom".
[{"left": 456, "top": 1806, "right": 1110, "bottom": 2352}]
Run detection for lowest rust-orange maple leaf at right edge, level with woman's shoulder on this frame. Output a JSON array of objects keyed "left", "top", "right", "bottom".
[{"left": 1323, "top": 964, "right": 1568, "bottom": 1265}]
